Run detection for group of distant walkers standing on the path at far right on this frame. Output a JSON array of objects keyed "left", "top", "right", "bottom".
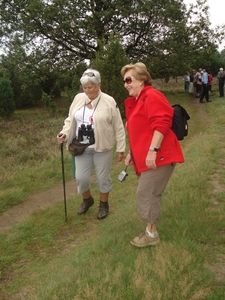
[{"left": 184, "top": 68, "right": 225, "bottom": 103}]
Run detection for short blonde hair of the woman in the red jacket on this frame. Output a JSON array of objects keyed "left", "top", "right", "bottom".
[{"left": 121, "top": 62, "right": 152, "bottom": 85}]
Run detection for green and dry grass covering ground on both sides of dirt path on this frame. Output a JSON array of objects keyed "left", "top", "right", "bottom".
[{"left": 0, "top": 85, "right": 225, "bottom": 300}]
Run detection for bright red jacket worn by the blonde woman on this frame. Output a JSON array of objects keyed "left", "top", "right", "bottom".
[{"left": 125, "top": 86, "right": 184, "bottom": 173}]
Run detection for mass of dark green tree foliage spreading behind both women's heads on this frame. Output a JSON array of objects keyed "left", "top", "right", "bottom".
[{"left": 0, "top": 0, "right": 225, "bottom": 109}]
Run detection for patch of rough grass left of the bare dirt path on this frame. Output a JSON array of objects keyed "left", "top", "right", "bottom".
[{"left": 0, "top": 109, "right": 70, "bottom": 212}]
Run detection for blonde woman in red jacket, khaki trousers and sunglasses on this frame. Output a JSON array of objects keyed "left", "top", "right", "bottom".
[{"left": 121, "top": 62, "right": 184, "bottom": 247}]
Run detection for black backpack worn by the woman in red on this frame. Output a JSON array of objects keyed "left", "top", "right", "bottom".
[{"left": 171, "top": 104, "right": 190, "bottom": 141}]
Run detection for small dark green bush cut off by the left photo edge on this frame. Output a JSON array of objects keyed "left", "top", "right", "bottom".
[{"left": 0, "top": 77, "right": 15, "bottom": 118}]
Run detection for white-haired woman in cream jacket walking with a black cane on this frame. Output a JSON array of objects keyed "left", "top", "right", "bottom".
[{"left": 57, "top": 69, "right": 125, "bottom": 220}]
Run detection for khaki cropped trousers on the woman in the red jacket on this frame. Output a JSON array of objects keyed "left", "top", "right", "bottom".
[{"left": 136, "top": 163, "right": 176, "bottom": 224}]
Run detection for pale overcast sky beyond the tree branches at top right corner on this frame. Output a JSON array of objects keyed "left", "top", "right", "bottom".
[{"left": 184, "top": 0, "right": 225, "bottom": 51}]
